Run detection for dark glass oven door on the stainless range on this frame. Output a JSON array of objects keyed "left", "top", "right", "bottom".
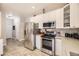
[{"left": 42, "top": 39, "right": 52, "bottom": 51}]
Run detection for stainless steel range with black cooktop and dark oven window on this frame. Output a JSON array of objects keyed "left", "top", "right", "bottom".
[{"left": 42, "top": 32, "right": 56, "bottom": 55}]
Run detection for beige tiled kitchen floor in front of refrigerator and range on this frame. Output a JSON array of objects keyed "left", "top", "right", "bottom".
[{"left": 4, "top": 39, "right": 49, "bottom": 56}]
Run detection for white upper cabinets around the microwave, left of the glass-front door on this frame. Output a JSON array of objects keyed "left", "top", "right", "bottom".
[{"left": 31, "top": 8, "right": 63, "bottom": 28}]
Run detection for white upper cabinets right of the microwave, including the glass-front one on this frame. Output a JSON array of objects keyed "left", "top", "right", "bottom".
[{"left": 55, "top": 3, "right": 79, "bottom": 28}]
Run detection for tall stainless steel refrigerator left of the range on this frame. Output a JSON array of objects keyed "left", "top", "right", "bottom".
[{"left": 24, "top": 22, "right": 36, "bottom": 50}]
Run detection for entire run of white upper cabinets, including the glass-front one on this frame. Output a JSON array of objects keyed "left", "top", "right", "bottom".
[{"left": 31, "top": 3, "right": 79, "bottom": 28}]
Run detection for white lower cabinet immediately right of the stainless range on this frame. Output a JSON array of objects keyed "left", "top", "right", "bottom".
[{"left": 55, "top": 38, "right": 62, "bottom": 56}]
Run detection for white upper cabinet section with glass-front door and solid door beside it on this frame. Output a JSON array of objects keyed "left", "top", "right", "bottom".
[{"left": 63, "top": 3, "right": 79, "bottom": 28}]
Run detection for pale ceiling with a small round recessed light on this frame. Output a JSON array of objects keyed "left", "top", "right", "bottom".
[{"left": 0, "top": 3, "right": 66, "bottom": 17}]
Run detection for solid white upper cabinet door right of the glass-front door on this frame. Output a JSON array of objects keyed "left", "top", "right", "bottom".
[{"left": 70, "top": 3, "right": 79, "bottom": 28}]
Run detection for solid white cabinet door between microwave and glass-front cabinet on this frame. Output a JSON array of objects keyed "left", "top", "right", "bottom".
[{"left": 56, "top": 8, "right": 63, "bottom": 28}]
